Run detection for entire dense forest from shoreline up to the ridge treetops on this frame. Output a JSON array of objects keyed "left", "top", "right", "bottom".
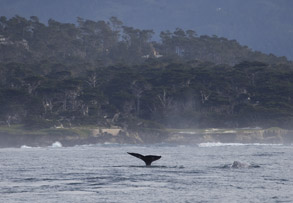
[{"left": 0, "top": 16, "right": 293, "bottom": 129}]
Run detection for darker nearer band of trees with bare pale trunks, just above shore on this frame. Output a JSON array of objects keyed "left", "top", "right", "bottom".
[{"left": 0, "top": 61, "right": 293, "bottom": 128}]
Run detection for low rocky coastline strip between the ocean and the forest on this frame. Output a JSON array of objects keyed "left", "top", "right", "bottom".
[{"left": 0, "top": 126, "right": 293, "bottom": 148}]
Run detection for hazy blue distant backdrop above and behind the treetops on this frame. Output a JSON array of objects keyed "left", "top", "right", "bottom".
[{"left": 0, "top": 0, "right": 293, "bottom": 60}]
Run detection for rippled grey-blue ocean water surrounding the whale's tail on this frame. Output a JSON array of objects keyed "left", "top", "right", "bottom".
[{"left": 0, "top": 142, "right": 293, "bottom": 203}]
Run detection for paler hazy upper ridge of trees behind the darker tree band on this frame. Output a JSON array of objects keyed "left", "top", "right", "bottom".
[{"left": 0, "top": 16, "right": 288, "bottom": 66}]
